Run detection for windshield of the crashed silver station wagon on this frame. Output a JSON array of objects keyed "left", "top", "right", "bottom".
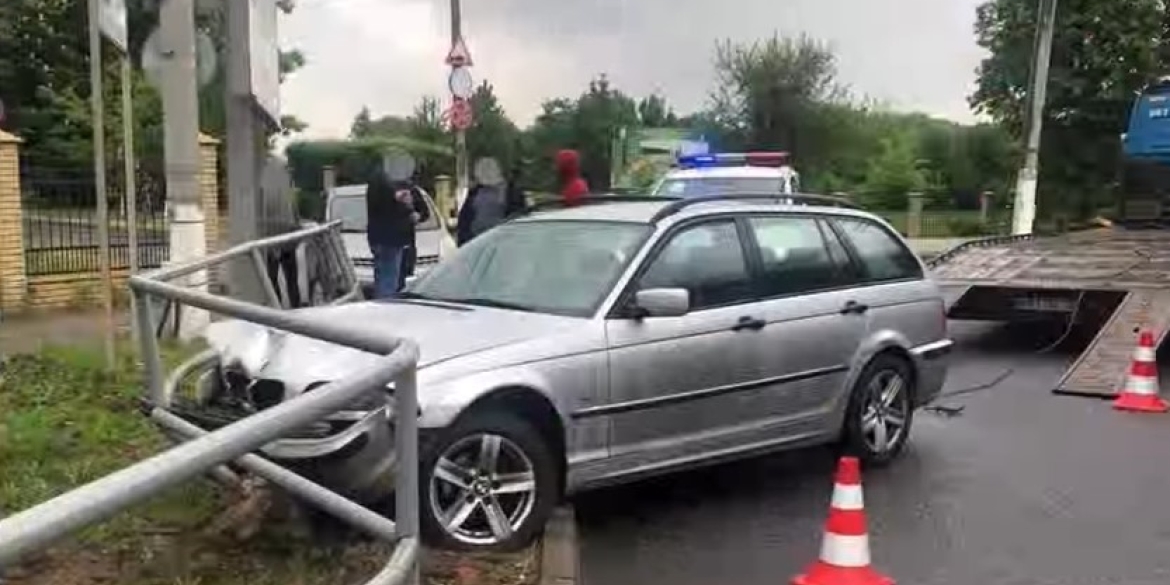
[{"left": 402, "top": 220, "right": 649, "bottom": 317}]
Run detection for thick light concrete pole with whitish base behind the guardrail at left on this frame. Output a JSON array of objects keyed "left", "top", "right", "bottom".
[{"left": 159, "top": 0, "right": 208, "bottom": 339}]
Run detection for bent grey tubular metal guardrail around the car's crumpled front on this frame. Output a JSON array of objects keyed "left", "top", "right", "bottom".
[{"left": 0, "top": 223, "right": 420, "bottom": 585}]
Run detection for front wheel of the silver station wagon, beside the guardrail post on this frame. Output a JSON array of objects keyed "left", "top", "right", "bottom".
[{"left": 419, "top": 411, "right": 560, "bottom": 551}]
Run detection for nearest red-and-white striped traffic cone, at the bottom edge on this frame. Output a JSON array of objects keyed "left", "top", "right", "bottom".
[{"left": 792, "top": 457, "right": 894, "bottom": 585}]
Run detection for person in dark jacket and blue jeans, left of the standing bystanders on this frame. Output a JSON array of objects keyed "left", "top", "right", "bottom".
[{"left": 366, "top": 151, "right": 431, "bottom": 298}]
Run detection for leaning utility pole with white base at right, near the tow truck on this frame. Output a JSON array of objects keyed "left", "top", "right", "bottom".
[{"left": 1012, "top": 0, "right": 1057, "bottom": 235}]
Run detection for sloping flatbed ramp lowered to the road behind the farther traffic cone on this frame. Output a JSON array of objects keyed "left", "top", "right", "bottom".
[{"left": 1053, "top": 290, "right": 1170, "bottom": 398}]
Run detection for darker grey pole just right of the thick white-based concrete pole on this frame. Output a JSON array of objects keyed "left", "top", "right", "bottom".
[{"left": 223, "top": 0, "right": 267, "bottom": 303}]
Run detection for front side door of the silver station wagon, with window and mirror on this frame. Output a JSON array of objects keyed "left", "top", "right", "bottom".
[{"left": 603, "top": 218, "right": 761, "bottom": 468}]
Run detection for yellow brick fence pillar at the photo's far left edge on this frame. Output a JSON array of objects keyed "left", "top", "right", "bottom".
[{"left": 0, "top": 130, "right": 28, "bottom": 311}]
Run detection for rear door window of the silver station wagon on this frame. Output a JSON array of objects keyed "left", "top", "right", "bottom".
[{"left": 748, "top": 216, "right": 841, "bottom": 296}]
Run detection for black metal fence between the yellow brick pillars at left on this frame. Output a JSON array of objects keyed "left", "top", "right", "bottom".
[{"left": 21, "top": 168, "right": 170, "bottom": 276}]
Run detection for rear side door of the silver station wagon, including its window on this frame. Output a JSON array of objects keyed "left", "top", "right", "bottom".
[{"left": 739, "top": 214, "right": 868, "bottom": 442}]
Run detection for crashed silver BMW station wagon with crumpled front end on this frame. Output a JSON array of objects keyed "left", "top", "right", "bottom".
[{"left": 205, "top": 195, "right": 951, "bottom": 549}]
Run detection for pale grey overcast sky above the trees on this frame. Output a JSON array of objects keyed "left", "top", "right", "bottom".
[{"left": 280, "top": 0, "right": 982, "bottom": 137}]
